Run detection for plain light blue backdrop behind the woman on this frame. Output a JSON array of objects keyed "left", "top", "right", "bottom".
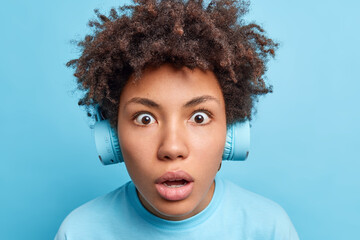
[{"left": 0, "top": 0, "right": 360, "bottom": 240}]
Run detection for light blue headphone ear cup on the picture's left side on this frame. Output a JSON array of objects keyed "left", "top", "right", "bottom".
[{"left": 94, "top": 120, "right": 124, "bottom": 165}]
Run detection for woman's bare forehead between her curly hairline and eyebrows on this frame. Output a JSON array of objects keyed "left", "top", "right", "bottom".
[{"left": 120, "top": 64, "right": 223, "bottom": 105}]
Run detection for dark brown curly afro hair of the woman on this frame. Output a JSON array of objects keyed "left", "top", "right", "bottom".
[{"left": 66, "top": 0, "right": 278, "bottom": 127}]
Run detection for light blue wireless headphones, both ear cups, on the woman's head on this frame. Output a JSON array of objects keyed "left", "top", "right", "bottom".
[{"left": 94, "top": 109, "right": 250, "bottom": 165}]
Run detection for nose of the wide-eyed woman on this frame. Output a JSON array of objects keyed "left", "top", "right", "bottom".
[{"left": 158, "top": 124, "right": 189, "bottom": 160}]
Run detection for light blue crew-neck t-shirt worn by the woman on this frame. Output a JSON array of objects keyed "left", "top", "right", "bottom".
[{"left": 55, "top": 177, "right": 299, "bottom": 240}]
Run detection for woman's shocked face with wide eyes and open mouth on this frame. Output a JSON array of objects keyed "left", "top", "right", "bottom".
[{"left": 118, "top": 65, "right": 226, "bottom": 220}]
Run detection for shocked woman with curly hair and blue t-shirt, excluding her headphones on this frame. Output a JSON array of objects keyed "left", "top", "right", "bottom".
[{"left": 56, "top": 0, "right": 298, "bottom": 239}]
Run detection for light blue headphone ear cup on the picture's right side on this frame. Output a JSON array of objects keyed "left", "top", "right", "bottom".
[{"left": 222, "top": 121, "right": 250, "bottom": 161}]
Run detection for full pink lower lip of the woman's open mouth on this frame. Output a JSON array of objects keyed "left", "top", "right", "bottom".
[{"left": 155, "top": 182, "right": 194, "bottom": 201}]
